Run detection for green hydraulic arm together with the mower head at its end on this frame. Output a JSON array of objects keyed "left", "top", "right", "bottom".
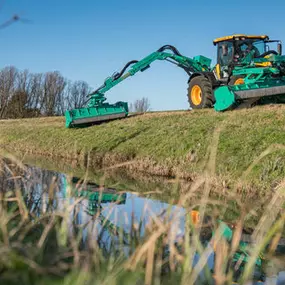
[{"left": 65, "top": 45, "right": 211, "bottom": 128}]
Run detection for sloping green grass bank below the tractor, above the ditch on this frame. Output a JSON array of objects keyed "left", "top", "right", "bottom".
[{"left": 0, "top": 106, "right": 285, "bottom": 185}]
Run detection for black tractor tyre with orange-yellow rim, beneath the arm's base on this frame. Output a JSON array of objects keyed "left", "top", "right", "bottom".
[{"left": 188, "top": 75, "right": 214, "bottom": 109}]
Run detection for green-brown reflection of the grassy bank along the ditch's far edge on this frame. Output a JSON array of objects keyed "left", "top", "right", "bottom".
[{"left": 3, "top": 148, "right": 274, "bottom": 230}]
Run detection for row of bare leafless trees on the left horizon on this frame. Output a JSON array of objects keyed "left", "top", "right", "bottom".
[{"left": 0, "top": 66, "right": 91, "bottom": 119}]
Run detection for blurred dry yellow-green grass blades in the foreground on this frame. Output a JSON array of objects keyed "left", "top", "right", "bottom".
[{"left": 0, "top": 146, "right": 285, "bottom": 285}]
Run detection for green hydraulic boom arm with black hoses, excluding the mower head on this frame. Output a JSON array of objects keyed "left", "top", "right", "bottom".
[{"left": 85, "top": 45, "right": 211, "bottom": 107}]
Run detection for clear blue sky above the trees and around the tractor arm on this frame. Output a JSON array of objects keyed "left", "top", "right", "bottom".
[{"left": 0, "top": 0, "right": 285, "bottom": 110}]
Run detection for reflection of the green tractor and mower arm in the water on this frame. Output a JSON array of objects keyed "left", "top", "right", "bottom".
[{"left": 61, "top": 174, "right": 285, "bottom": 284}]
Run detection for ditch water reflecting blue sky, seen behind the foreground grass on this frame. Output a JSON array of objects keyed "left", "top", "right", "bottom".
[{"left": 0, "top": 158, "right": 285, "bottom": 284}]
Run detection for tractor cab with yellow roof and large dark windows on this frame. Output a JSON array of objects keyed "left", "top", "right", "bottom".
[{"left": 213, "top": 35, "right": 282, "bottom": 80}]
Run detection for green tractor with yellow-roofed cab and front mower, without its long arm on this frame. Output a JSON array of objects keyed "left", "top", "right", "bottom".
[{"left": 206, "top": 35, "right": 285, "bottom": 111}]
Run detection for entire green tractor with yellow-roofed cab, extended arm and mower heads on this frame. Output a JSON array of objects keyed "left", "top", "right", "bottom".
[{"left": 65, "top": 34, "right": 285, "bottom": 128}]
